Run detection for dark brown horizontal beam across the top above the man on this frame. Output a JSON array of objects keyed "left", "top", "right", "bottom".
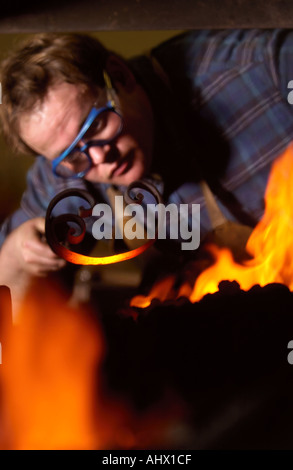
[{"left": 0, "top": 0, "right": 293, "bottom": 33}]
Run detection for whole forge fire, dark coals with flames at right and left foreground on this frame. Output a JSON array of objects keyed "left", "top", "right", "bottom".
[{"left": 0, "top": 147, "right": 293, "bottom": 449}]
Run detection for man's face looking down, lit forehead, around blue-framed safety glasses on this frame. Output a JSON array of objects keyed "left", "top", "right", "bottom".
[{"left": 20, "top": 75, "right": 153, "bottom": 185}]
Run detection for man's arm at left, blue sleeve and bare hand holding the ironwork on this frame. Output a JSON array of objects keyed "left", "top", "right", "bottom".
[{"left": 0, "top": 156, "right": 74, "bottom": 314}]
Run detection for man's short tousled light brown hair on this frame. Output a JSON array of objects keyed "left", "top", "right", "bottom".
[{"left": 0, "top": 33, "right": 110, "bottom": 153}]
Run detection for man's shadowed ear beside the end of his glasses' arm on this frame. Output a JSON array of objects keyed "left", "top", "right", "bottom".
[{"left": 105, "top": 55, "right": 137, "bottom": 93}]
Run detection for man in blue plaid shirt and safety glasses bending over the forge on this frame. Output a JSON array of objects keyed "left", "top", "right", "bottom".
[{"left": 0, "top": 30, "right": 293, "bottom": 308}]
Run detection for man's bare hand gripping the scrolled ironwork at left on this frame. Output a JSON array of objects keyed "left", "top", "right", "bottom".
[{"left": 0, "top": 217, "right": 66, "bottom": 281}]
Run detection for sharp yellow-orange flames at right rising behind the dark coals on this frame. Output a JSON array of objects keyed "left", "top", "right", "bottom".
[{"left": 131, "top": 144, "right": 293, "bottom": 307}]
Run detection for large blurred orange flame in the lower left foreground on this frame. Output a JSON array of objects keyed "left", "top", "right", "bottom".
[{"left": 0, "top": 284, "right": 126, "bottom": 450}]
